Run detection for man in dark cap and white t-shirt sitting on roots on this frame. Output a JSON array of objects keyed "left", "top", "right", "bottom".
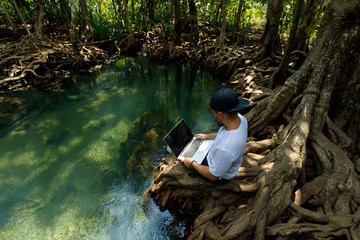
[{"left": 182, "top": 88, "right": 249, "bottom": 181}]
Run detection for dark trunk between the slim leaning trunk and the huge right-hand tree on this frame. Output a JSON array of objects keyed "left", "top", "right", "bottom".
[{"left": 293, "top": 0, "right": 319, "bottom": 52}]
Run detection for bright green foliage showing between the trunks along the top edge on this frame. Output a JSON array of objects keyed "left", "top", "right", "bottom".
[{"left": 0, "top": 0, "right": 326, "bottom": 45}]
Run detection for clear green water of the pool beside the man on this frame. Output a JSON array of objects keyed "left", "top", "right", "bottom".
[{"left": 0, "top": 58, "right": 221, "bottom": 239}]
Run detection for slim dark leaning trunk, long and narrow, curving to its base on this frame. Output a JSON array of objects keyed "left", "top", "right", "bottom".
[{"left": 268, "top": 0, "right": 304, "bottom": 88}]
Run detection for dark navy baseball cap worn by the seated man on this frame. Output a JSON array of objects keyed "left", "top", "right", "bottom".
[{"left": 210, "top": 88, "right": 249, "bottom": 112}]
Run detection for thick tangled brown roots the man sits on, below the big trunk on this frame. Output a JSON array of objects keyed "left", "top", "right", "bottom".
[{"left": 146, "top": 39, "right": 360, "bottom": 239}]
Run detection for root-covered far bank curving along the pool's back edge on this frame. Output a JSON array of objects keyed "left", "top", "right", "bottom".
[{"left": 0, "top": 26, "right": 259, "bottom": 93}]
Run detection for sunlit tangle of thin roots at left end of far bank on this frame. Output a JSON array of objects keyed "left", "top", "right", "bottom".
[{"left": 0, "top": 36, "right": 107, "bottom": 91}]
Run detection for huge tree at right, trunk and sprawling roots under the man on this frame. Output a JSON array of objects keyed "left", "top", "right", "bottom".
[{"left": 144, "top": 0, "right": 360, "bottom": 239}]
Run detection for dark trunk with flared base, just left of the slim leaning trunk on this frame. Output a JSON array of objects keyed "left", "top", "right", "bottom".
[{"left": 256, "top": 0, "right": 284, "bottom": 60}]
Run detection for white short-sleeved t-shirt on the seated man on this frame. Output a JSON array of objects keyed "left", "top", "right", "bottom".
[{"left": 207, "top": 114, "right": 248, "bottom": 179}]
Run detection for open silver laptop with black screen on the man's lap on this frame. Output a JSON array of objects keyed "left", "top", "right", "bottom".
[{"left": 164, "top": 119, "right": 214, "bottom": 164}]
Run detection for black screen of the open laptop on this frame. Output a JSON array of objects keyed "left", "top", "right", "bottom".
[{"left": 164, "top": 119, "right": 193, "bottom": 156}]
